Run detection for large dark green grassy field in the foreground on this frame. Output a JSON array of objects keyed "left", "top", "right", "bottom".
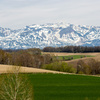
[{"left": 25, "top": 74, "right": 100, "bottom": 100}]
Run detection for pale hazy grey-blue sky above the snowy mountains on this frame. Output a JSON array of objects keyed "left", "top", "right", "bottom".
[{"left": 0, "top": 0, "right": 100, "bottom": 29}]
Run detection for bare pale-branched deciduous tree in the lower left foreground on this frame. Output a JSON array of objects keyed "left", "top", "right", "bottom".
[{"left": 0, "top": 67, "right": 33, "bottom": 100}]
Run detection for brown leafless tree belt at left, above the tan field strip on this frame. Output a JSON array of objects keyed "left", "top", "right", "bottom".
[{"left": 0, "top": 48, "right": 53, "bottom": 68}]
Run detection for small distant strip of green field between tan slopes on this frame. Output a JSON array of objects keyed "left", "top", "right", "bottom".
[{"left": 57, "top": 55, "right": 93, "bottom": 60}]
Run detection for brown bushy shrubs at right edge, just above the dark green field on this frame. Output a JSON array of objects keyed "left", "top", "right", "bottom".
[{"left": 76, "top": 59, "right": 100, "bottom": 75}]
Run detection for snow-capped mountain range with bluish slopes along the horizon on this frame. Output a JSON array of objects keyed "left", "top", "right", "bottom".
[{"left": 0, "top": 23, "right": 100, "bottom": 49}]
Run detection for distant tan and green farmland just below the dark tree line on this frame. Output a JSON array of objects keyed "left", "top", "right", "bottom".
[{"left": 43, "top": 52, "right": 100, "bottom": 68}]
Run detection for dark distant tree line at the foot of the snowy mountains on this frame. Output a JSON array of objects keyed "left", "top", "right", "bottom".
[{"left": 43, "top": 46, "right": 100, "bottom": 53}]
